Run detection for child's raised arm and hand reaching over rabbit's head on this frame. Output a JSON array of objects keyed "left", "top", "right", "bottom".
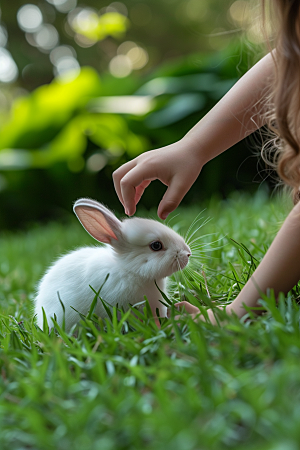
[{"left": 113, "top": 53, "right": 274, "bottom": 219}]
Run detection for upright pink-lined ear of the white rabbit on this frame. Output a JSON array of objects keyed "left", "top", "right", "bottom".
[{"left": 73, "top": 198, "right": 121, "bottom": 244}]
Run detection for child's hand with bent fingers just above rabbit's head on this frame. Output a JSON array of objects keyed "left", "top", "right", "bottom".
[{"left": 113, "top": 140, "right": 202, "bottom": 220}]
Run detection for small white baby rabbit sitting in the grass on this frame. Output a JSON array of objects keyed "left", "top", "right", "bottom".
[{"left": 35, "top": 198, "right": 191, "bottom": 331}]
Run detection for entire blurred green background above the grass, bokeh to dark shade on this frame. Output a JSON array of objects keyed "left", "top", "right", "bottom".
[{"left": 0, "top": 0, "right": 268, "bottom": 228}]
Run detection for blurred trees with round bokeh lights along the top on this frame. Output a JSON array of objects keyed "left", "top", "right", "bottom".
[{"left": 0, "top": 0, "right": 258, "bottom": 90}]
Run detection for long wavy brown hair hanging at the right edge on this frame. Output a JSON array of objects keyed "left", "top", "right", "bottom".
[{"left": 262, "top": 0, "right": 300, "bottom": 203}]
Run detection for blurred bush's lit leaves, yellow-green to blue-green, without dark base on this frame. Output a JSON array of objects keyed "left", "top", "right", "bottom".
[{"left": 0, "top": 40, "right": 248, "bottom": 172}]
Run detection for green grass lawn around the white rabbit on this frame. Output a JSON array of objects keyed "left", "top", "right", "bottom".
[{"left": 0, "top": 193, "right": 300, "bottom": 450}]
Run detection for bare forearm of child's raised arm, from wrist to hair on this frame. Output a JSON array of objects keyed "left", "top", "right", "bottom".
[{"left": 182, "top": 53, "right": 274, "bottom": 163}]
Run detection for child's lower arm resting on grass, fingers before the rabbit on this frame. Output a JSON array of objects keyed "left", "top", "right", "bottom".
[{"left": 177, "top": 203, "right": 300, "bottom": 323}]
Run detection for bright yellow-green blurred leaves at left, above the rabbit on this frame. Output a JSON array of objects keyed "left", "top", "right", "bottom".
[{"left": 0, "top": 67, "right": 144, "bottom": 172}]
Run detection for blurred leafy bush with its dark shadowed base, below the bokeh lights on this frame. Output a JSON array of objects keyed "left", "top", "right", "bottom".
[{"left": 0, "top": 38, "right": 268, "bottom": 227}]
